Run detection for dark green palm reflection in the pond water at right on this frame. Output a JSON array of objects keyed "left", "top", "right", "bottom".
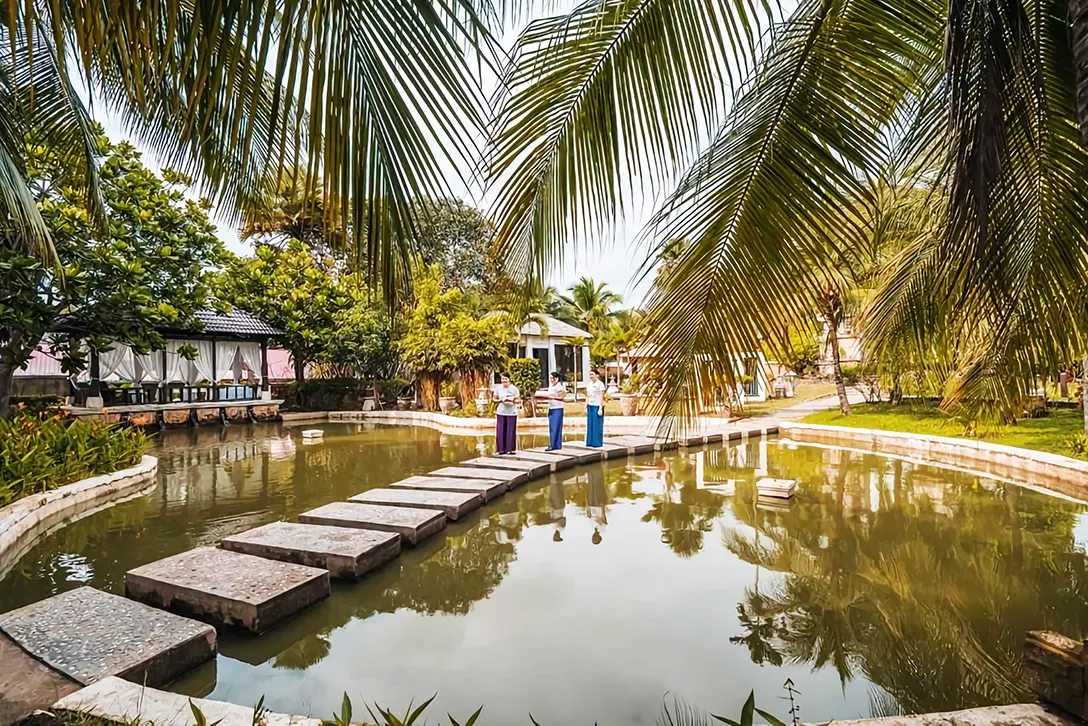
[{"left": 725, "top": 450, "right": 1088, "bottom": 713}]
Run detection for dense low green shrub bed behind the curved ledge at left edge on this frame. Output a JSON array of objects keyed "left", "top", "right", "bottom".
[{"left": 0, "top": 415, "right": 148, "bottom": 506}]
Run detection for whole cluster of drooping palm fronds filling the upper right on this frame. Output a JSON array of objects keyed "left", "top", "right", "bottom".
[{"left": 490, "top": 0, "right": 1088, "bottom": 426}]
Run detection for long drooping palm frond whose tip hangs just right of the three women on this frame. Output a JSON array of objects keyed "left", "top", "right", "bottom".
[{"left": 647, "top": 0, "right": 941, "bottom": 427}]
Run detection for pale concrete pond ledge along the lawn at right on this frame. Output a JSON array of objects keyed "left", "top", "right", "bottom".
[{"left": 780, "top": 421, "right": 1088, "bottom": 501}]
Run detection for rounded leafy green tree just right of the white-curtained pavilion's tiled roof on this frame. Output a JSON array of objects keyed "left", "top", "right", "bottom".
[{"left": 215, "top": 239, "right": 343, "bottom": 381}]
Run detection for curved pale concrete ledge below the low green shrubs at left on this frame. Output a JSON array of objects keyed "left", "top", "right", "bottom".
[{"left": 0, "top": 456, "right": 159, "bottom": 576}]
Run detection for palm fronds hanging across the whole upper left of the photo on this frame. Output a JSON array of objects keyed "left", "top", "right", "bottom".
[{"left": 0, "top": 0, "right": 492, "bottom": 293}]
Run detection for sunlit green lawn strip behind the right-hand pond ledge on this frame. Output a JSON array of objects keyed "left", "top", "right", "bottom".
[{"left": 803, "top": 404, "right": 1088, "bottom": 458}]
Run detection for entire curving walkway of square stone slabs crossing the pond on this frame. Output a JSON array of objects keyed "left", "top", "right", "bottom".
[{"left": 0, "top": 420, "right": 783, "bottom": 715}]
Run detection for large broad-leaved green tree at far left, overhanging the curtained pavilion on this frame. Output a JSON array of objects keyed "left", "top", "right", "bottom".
[{"left": 0, "top": 127, "right": 223, "bottom": 417}]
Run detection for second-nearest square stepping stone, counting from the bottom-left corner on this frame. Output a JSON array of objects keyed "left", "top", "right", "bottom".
[{"left": 125, "top": 547, "right": 329, "bottom": 632}]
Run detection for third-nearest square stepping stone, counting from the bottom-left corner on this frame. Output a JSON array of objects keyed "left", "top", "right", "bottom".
[{"left": 220, "top": 521, "right": 400, "bottom": 580}]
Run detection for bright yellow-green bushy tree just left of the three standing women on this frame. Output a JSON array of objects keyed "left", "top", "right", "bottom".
[{"left": 394, "top": 264, "right": 509, "bottom": 410}]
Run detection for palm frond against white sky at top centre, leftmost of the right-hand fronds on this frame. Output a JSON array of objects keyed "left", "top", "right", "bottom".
[{"left": 486, "top": 0, "right": 772, "bottom": 276}]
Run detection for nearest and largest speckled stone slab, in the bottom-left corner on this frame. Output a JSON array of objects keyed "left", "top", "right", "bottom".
[{"left": 0, "top": 588, "right": 215, "bottom": 686}]
